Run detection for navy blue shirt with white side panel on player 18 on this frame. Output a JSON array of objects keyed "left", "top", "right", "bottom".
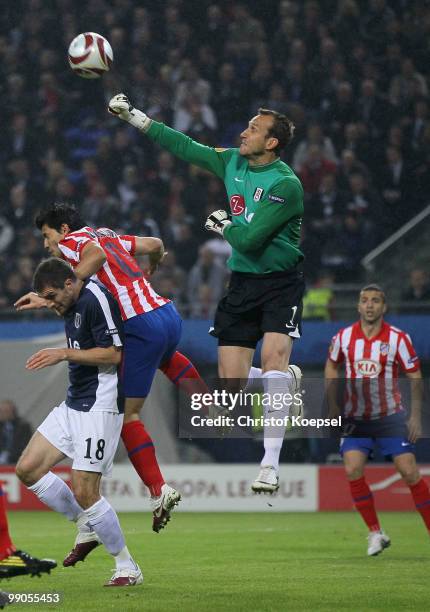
[{"left": 64, "top": 280, "right": 124, "bottom": 413}]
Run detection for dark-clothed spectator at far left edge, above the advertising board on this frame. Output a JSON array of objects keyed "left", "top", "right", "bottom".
[{"left": 0, "top": 399, "right": 33, "bottom": 465}]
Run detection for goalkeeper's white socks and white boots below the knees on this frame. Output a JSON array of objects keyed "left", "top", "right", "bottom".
[{"left": 251, "top": 365, "right": 302, "bottom": 494}]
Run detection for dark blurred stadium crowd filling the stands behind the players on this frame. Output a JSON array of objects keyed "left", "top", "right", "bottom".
[{"left": 0, "top": 0, "right": 430, "bottom": 318}]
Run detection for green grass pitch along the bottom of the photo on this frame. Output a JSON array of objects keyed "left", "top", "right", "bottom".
[{"left": 0, "top": 512, "right": 430, "bottom": 612}]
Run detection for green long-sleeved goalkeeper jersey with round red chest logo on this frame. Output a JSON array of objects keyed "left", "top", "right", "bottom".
[{"left": 147, "top": 121, "right": 303, "bottom": 274}]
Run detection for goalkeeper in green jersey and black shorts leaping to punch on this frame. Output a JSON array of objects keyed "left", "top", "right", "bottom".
[{"left": 109, "top": 94, "right": 304, "bottom": 493}]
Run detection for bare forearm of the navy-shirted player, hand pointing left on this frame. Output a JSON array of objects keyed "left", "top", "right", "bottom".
[{"left": 25, "top": 346, "right": 121, "bottom": 370}]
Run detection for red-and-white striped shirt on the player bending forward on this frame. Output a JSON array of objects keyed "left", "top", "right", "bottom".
[{"left": 58, "top": 227, "right": 170, "bottom": 321}]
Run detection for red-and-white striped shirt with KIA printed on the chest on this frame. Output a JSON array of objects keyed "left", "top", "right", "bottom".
[{"left": 328, "top": 321, "right": 420, "bottom": 420}]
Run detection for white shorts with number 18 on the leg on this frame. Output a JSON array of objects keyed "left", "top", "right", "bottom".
[{"left": 37, "top": 402, "right": 124, "bottom": 476}]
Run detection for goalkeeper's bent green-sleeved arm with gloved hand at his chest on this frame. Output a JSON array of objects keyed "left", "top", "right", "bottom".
[{"left": 205, "top": 181, "right": 303, "bottom": 253}]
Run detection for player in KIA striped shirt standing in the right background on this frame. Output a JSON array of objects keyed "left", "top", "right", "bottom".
[{"left": 325, "top": 284, "right": 430, "bottom": 555}]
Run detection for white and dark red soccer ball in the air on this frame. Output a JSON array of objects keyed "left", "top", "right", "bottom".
[{"left": 68, "top": 32, "right": 113, "bottom": 79}]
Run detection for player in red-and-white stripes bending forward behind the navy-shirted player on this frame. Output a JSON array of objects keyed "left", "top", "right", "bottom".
[{"left": 15, "top": 204, "right": 207, "bottom": 532}]
